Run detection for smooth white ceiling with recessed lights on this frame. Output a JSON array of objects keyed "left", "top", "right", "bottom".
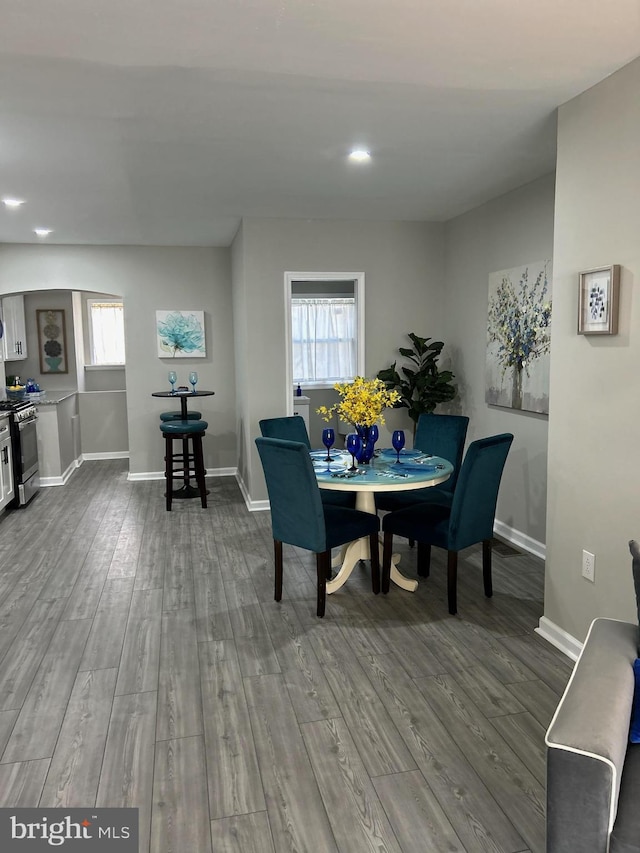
[{"left": 0, "top": 0, "right": 640, "bottom": 246}]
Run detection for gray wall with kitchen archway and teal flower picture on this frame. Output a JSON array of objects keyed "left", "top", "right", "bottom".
[{"left": 0, "top": 245, "right": 237, "bottom": 474}]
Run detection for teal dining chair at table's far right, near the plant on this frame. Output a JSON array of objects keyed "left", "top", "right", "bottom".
[{"left": 375, "top": 414, "right": 469, "bottom": 512}]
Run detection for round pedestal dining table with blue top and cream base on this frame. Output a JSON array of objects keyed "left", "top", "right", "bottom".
[{"left": 309, "top": 448, "right": 453, "bottom": 593}]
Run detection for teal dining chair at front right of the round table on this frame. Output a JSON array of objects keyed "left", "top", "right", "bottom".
[{"left": 382, "top": 433, "right": 513, "bottom": 614}]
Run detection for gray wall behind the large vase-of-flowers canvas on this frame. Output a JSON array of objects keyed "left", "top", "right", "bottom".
[{"left": 444, "top": 175, "right": 558, "bottom": 553}]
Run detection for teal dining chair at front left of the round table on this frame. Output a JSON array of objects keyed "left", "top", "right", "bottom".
[{"left": 256, "top": 438, "right": 380, "bottom": 617}]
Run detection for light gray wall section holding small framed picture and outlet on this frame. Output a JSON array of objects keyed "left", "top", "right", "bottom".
[{"left": 545, "top": 60, "right": 640, "bottom": 640}]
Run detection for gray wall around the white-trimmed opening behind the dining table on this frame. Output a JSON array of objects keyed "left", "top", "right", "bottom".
[{"left": 233, "top": 219, "right": 444, "bottom": 500}]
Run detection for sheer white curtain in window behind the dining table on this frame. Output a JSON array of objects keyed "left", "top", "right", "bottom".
[{"left": 291, "top": 297, "right": 356, "bottom": 383}]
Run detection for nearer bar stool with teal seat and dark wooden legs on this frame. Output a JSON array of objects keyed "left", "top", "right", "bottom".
[{"left": 160, "top": 420, "right": 209, "bottom": 512}]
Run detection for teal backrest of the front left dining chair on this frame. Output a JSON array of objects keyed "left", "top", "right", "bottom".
[{"left": 256, "top": 440, "right": 327, "bottom": 553}]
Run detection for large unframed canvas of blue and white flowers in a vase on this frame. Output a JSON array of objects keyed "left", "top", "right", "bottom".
[{"left": 485, "top": 260, "right": 551, "bottom": 414}]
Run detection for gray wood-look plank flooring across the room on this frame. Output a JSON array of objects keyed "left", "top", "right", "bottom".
[{"left": 0, "top": 461, "right": 571, "bottom": 853}]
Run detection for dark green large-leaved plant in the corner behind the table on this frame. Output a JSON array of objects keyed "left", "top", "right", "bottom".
[{"left": 377, "top": 332, "right": 457, "bottom": 433}]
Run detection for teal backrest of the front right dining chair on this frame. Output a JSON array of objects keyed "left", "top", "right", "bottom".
[{"left": 448, "top": 432, "right": 513, "bottom": 551}]
